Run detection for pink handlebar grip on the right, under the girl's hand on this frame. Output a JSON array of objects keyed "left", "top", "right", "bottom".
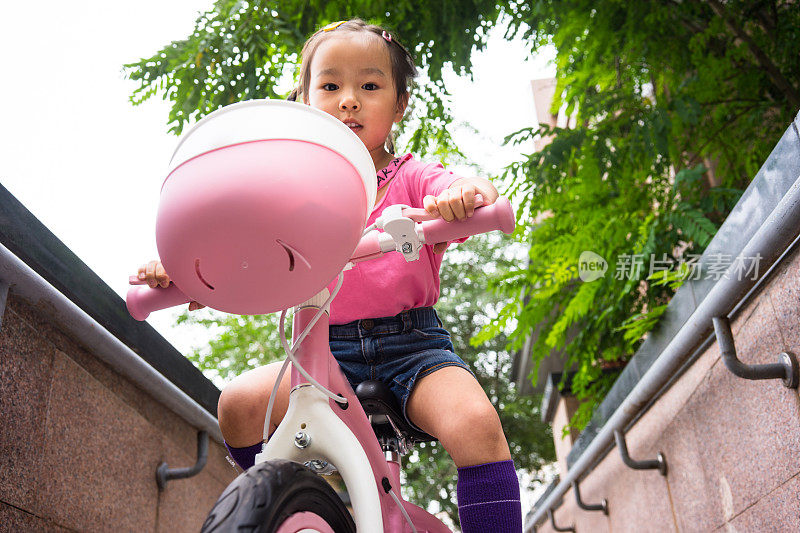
[{"left": 421, "top": 196, "right": 516, "bottom": 244}]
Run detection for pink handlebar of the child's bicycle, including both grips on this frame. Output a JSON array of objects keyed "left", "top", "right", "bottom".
[{"left": 125, "top": 197, "right": 516, "bottom": 320}]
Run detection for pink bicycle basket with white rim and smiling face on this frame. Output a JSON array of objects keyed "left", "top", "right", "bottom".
[{"left": 156, "top": 100, "right": 377, "bottom": 315}]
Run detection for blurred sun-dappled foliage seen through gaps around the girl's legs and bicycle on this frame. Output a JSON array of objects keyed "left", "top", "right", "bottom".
[{"left": 179, "top": 235, "right": 555, "bottom": 524}]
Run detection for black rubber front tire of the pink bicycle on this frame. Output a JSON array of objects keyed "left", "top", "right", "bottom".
[{"left": 201, "top": 459, "right": 356, "bottom": 533}]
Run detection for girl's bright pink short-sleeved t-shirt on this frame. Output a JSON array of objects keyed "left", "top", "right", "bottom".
[{"left": 328, "top": 154, "right": 461, "bottom": 324}]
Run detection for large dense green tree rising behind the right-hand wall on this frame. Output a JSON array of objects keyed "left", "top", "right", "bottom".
[{"left": 484, "top": 0, "right": 800, "bottom": 427}]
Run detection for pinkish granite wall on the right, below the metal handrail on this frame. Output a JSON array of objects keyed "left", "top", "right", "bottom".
[{"left": 538, "top": 243, "right": 800, "bottom": 533}]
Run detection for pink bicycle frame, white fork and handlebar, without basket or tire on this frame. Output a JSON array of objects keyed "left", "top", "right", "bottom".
[{"left": 126, "top": 197, "right": 515, "bottom": 533}]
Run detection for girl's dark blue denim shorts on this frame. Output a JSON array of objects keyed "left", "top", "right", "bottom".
[{"left": 330, "top": 307, "right": 475, "bottom": 429}]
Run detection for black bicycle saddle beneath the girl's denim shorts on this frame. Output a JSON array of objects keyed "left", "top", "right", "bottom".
[{"left": 356, "top": 380, "right": 436, "bottom": 444}]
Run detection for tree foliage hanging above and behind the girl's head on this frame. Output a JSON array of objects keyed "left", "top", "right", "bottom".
[{"left": 124, "top": 0, "right": 500, "bottom": 156}]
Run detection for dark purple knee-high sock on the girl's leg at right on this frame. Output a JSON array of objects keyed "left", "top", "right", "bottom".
[{"left": 456, "top": 459, "right": 522, "bottom": 533}]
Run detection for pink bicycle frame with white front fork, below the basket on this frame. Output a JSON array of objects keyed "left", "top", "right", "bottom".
[{"left": 256, "top": 298, "right": 450, "bottom": 533}]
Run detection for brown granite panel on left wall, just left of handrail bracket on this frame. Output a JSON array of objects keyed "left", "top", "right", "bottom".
[{"left": 37, "top": 352, "right": 163, "bottom": 531}]
